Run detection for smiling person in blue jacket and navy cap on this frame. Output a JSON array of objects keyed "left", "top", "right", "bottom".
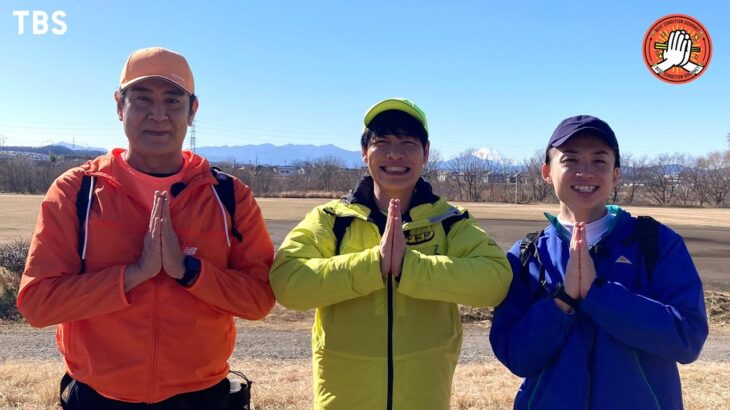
[{"left": 490, "top": 115, "right": 708, "bottom": 409}]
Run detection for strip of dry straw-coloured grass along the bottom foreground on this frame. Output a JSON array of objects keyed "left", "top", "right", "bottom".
[{"left": 0, "top": 360, "right": 730, "bottom": 410}]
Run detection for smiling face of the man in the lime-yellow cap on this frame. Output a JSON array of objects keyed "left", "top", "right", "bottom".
[{"left": 362, "top": 134, "right": 429, "bottom": 209}]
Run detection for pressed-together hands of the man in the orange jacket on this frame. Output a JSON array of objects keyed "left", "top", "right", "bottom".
[{"left": 124, "top": 191, "right": 185, "bottom": 292}]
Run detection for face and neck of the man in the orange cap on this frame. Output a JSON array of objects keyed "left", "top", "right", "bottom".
[{"left": 115, "top": 78, "right": 197, "bottom": 171}]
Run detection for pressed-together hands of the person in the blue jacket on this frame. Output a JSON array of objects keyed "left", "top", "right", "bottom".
[{"left": 554, "top": 222, "right": 596, "bottom": 312}]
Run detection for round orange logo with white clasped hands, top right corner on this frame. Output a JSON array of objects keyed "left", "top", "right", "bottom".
[{"left": 643, "top": 14, "right": 712, "bottom": 84}]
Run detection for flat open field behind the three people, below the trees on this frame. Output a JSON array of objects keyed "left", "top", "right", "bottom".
[{"left": 0, "top": 194, "right": 730, "bottom": 291}]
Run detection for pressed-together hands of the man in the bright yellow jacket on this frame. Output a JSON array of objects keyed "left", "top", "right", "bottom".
[{"left": 380, "top": 199, "right": 406, "bottom": 279}]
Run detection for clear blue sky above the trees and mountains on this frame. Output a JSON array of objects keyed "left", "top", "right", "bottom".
[{"left": 0, "top": 0, "right": 730, "bottom": 161}]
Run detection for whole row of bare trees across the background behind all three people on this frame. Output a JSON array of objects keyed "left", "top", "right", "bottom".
[{"left": 0, "top": 150, "right": 730, "bottom": 207}]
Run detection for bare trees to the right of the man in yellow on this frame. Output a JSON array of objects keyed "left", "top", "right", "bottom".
[{"left": 439, "top": 150, "right": 730, "bottom": 207}]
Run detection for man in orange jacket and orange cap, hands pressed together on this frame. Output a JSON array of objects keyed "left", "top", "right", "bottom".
[{"left": 17, "top": 48, "right": 274, "bottom": 409}]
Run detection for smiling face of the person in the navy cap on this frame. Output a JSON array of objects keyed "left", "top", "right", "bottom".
[{"left": 542, "top": 135, "right": 619, "bottom": 223}]
